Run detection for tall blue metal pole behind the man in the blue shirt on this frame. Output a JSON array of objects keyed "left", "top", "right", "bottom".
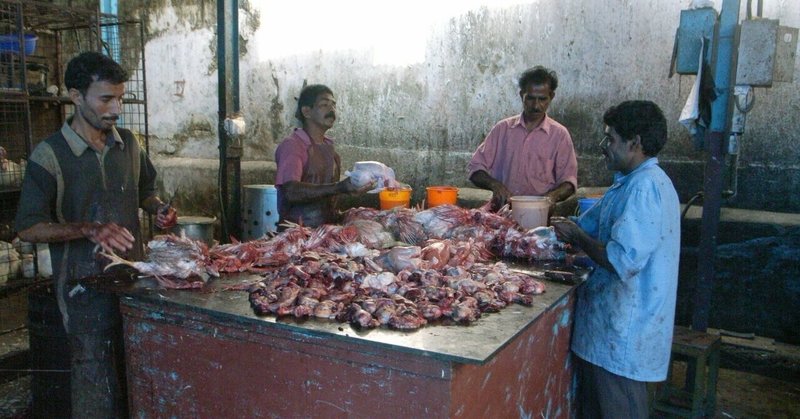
[{"left": 692, "top": 0, "right": 740, "bottom": 331}]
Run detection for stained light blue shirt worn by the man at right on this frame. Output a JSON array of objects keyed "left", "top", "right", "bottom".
[{"left": 572, "top": 158, "right": 680, "bottom": 381}]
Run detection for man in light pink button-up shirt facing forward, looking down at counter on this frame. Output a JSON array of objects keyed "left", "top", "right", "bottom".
[{"left": 467, "top": 66, "right": 578, "bottom": 210}]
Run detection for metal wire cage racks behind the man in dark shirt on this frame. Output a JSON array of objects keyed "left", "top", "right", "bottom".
[{"left": 0, "top": 0, "right": 150, "bottom": 286}]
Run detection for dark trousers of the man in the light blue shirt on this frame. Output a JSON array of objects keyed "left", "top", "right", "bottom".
[{"left": 573, "top": 356, "right": 649, "bottom": 419}]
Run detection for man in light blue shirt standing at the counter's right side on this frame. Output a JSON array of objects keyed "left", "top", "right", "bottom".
[{"left": 551, "top": 101, "right": 680, "bottom": 418}]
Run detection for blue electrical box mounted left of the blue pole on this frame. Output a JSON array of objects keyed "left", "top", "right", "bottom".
[{"left": 675, "top": 7, "right": 717, "bottom": 74}]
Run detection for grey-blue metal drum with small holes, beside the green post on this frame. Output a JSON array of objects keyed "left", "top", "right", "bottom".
[{"left": 242, "top": 185, "right": 279, "bottom": 240}]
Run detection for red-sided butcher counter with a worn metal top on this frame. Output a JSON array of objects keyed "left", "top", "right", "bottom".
[{"left": 106, "top": 267, "right": 575, "bottom": 418}]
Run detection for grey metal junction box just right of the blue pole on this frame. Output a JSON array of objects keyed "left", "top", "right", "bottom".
[{"left": 736, "top": 19, "right": 778, "bottom": 87}]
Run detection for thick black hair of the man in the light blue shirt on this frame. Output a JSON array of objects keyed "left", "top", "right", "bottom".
[{"left": 603, "top": 100, "right": 667, "bottom": 157}]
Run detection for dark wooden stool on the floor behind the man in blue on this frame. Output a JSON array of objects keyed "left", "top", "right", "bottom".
[{"left": 653, "top": 326, "right": 722, "bottom": 418}]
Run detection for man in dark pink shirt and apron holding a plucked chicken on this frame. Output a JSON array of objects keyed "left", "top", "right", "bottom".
[{"left": 275, "top": 84, "right": 372, "bottom": 227}]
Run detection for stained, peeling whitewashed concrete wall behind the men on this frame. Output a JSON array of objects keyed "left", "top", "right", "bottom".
[{"left": 108, "top": 0, "right": 800, "bottom": 342}]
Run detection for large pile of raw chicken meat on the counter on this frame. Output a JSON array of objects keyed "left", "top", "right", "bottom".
[{"left": 114, "top": 205, "right": 565, "bottom": 329}]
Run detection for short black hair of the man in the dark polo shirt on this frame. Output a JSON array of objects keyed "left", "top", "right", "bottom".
[{"left": 64, "top": 51, "right": 128, "bottom": 95}]
